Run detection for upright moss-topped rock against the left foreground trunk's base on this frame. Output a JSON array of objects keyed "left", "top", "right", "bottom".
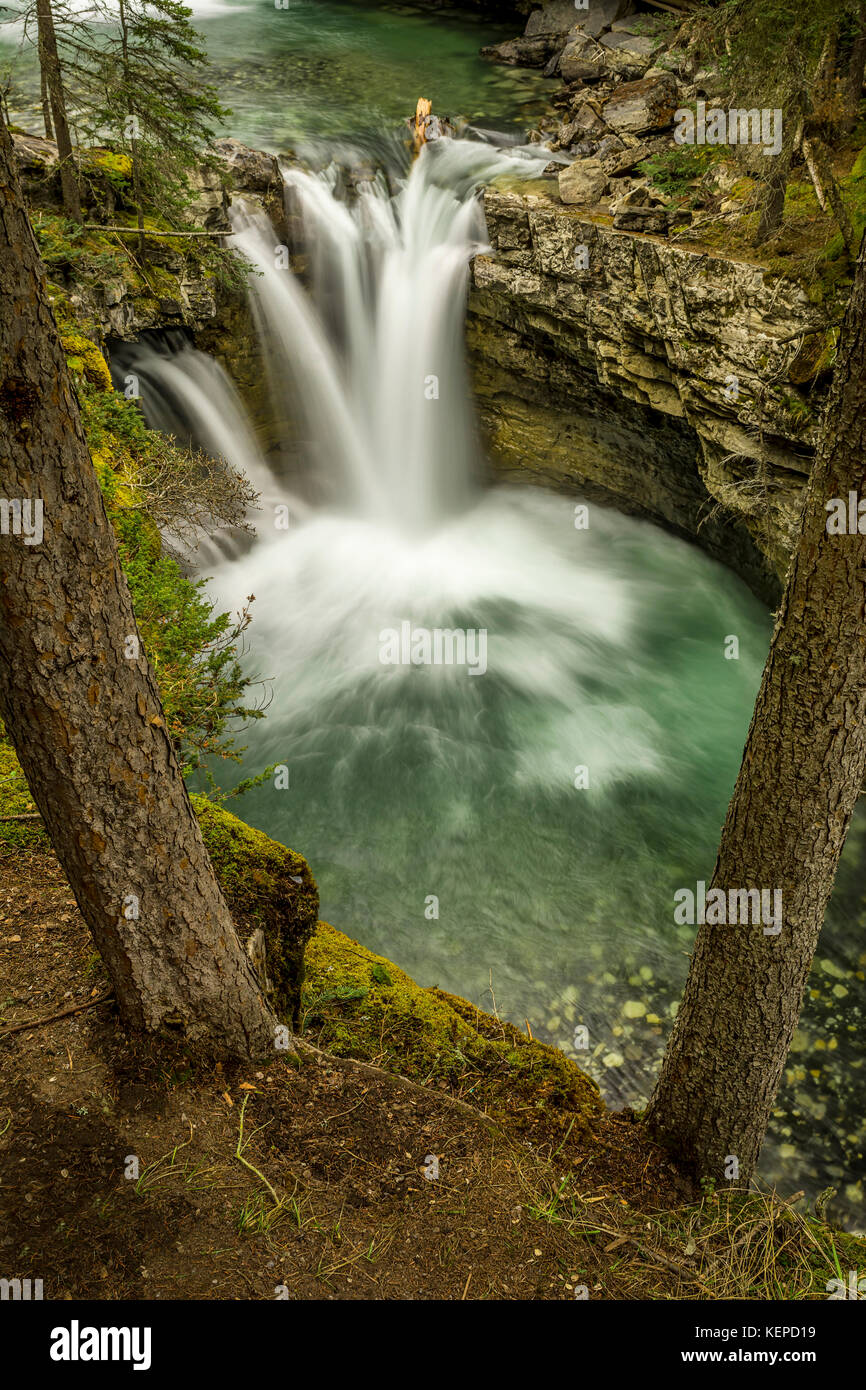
[{"left": 192, "top": 796, "right": 318, "bottom": 1026}]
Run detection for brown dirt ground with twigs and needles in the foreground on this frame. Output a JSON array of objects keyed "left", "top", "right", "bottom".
[{"left": 0, "top": 849, "right": 856, "bottom": 1300}]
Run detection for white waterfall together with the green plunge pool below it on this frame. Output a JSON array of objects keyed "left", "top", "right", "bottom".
[{"left": 116, "top": 140, "right": 783, "bottom": 1184}]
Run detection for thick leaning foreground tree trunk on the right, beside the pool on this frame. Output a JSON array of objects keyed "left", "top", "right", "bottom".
[{"left": 646, "top": 227, "right": 866, "bottom": 1182}]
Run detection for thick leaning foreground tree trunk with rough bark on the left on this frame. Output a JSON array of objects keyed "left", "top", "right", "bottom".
[{"left": 0, "top": 113, "right": 275, "bottom": 1056}]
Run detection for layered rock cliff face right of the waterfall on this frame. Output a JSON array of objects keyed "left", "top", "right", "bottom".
[{"left": 468, "top": 181, "right": 828, "bottom": 600}]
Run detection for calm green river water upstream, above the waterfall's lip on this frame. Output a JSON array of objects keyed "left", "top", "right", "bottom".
[{"left": 0, "top": 0, "right": 552, "bottom": 153}]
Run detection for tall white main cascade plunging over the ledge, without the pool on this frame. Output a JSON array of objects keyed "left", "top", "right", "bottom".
[{"left": 226, "top": 140, "right": 548, "bottom": 527}]
